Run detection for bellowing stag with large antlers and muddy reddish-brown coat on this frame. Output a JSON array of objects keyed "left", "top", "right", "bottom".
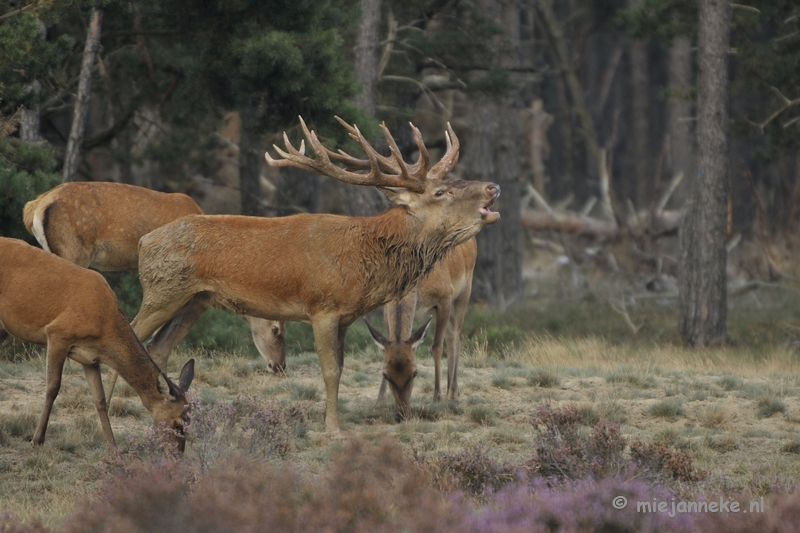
[{"left": 131, "top": 118, "right": 500, "bottom": 431}]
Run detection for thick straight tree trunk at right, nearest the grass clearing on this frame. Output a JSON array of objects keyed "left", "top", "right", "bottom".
[{"left": 678, "top": 0, "right": 731, "bottom": 346}]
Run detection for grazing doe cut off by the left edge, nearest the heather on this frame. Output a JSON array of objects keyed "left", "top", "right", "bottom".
[{"left": 0, "top": 237, "right": 194, "bottom": 451}]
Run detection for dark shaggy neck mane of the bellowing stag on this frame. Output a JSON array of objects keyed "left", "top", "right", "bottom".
[{"left": 358, "top": 206, "right": 459, "bottom": 306}]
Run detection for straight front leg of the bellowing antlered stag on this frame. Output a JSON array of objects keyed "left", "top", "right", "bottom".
[{"left": 311, "top": 317, "right": 346, "bottom": 433}]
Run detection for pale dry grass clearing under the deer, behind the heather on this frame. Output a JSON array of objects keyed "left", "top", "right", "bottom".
[{"left": 0, "top": 272, "right": 800, "bottom": 525}]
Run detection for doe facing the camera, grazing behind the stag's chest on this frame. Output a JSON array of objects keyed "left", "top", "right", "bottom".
[{"left": 367, "top": 238, "right": 478, "bottom": 418}]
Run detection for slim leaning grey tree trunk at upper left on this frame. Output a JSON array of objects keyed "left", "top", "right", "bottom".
[{"left": 61, "top": 8, "right": 103, "bottom": 182}]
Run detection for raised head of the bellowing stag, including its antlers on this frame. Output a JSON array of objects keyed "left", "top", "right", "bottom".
[{"left": 265, "top": 117, "right": 500, "bottom": 245}]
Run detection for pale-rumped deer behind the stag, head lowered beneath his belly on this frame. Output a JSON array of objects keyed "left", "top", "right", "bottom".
[{"left": 23, "top": 182, "right": 286, "bottom": 376}]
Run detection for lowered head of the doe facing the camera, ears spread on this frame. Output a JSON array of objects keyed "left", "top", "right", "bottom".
[{"left": 364, "top": 318, "right": 431, "bottom": 421}]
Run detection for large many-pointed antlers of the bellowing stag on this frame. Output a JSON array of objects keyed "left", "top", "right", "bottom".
[{"left": 265, "top": 117, "right": 459, "bottom": 192}]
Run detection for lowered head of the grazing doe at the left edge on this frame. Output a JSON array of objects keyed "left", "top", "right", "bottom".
[{"left": 151, "top": 359, "right": 194, "bottom": 452}]
